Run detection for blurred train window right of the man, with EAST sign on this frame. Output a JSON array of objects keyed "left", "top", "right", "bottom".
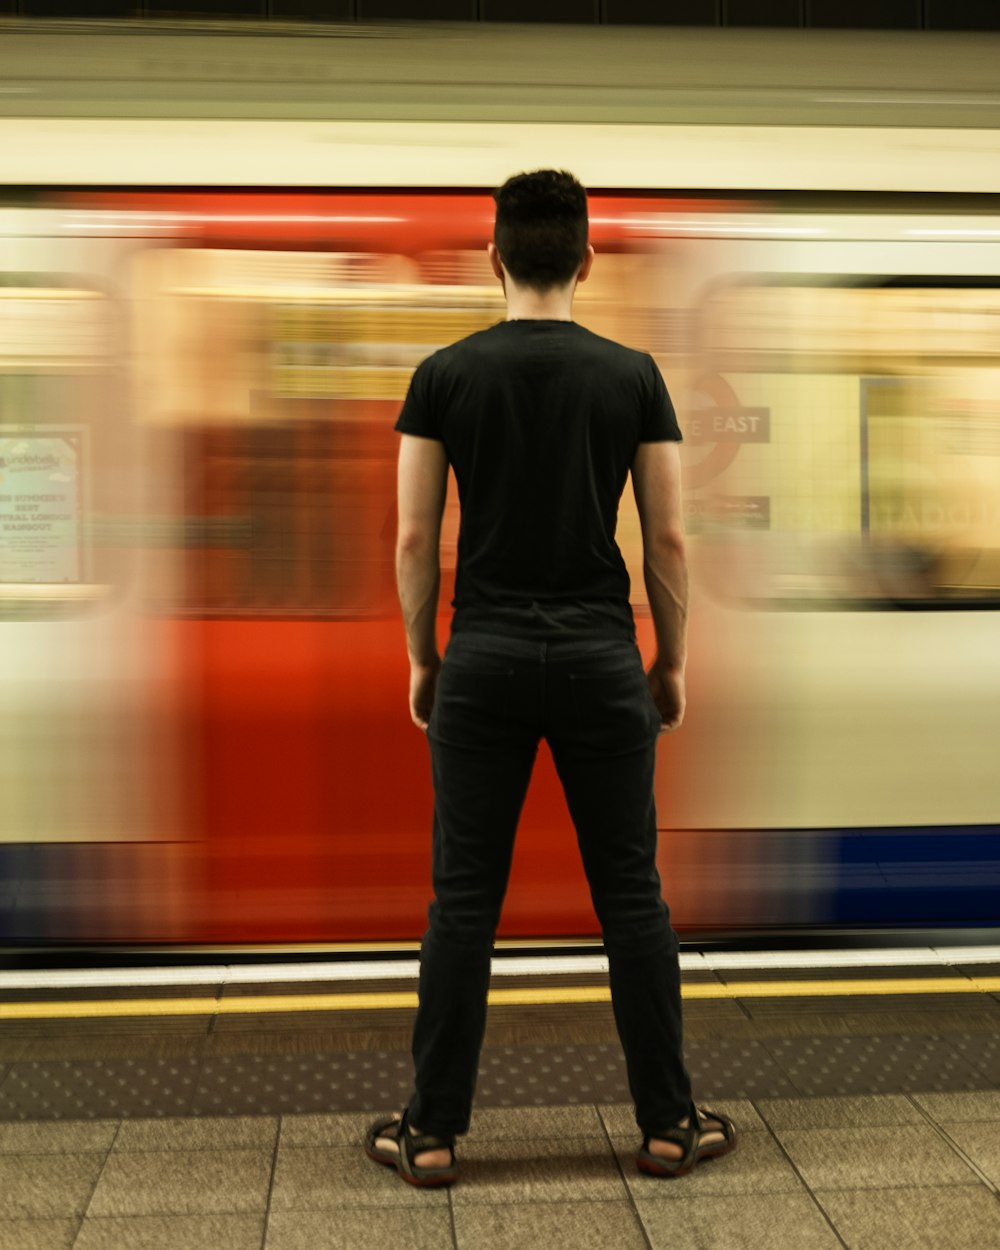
[{"left": 688, "top": 281, "right": 1000, "bottom": 608}]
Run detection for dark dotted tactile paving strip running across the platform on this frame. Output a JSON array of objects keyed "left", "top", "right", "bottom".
[{"left": 0, "top": 1035, "right": 1000, "bottom": 1120}]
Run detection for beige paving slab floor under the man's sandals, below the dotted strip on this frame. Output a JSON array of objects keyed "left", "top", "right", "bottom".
[{"left": 0, "top": 1090, "right": 1000, "bottom": 1250}]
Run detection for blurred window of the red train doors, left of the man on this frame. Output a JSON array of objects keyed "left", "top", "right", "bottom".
[{"left": 134, "top": 249, "right": 503, "bottom": 616}]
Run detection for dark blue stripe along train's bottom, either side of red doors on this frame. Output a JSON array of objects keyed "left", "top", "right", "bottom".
[{"left": 0, "top": 825, "right": 1000, "bottom": 943}]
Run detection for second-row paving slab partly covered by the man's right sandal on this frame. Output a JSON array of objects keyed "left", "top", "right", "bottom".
[{"left": 614, "top": 1133, "right": 803, "bottom": 1203}]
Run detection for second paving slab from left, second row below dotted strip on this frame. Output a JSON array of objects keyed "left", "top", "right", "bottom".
[{"left": 88, "top": 1150, "right": 273, "bottom": 1216}]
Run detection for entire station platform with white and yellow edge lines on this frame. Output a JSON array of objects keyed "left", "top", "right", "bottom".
[{"left": 0, "top": 948, "right": 1000, "bottom": 1250}]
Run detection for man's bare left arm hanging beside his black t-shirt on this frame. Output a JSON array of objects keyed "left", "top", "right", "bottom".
[{"left": 396, "top": 434, "right": 448, "bottom": 729}]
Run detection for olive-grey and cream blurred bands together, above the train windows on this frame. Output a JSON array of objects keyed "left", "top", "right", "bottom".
[{"left": 0, "top": 20, "right": 1000, "bottom": 193}]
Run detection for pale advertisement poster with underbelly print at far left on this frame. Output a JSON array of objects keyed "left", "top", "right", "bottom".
[{"left": 0, "top": 428, "right": 83, "bottom": 584}]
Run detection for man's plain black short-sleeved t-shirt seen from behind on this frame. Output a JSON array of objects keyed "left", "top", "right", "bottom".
[{"left": 396, "top": 320, "right": 681, "bottom": 639}]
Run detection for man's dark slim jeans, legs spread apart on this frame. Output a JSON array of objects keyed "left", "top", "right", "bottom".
[{"left": 410, "top": 633, "right": 691, "bottom": 1136}]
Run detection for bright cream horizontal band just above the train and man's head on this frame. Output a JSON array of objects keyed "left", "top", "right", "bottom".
[{"left": 0, "top": 118, "right": 1000, "bottom": 194}]
